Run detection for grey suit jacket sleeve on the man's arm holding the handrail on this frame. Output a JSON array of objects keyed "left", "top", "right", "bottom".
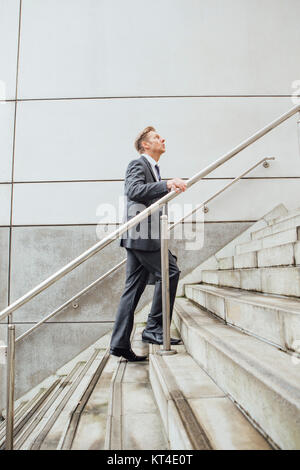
[{"left": 125, "top": 160, "right": 169, "bottom": 202}]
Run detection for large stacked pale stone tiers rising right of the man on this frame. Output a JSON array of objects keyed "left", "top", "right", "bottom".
[{"left": 174, "top": 204, "right": 300, "bottom": 449}]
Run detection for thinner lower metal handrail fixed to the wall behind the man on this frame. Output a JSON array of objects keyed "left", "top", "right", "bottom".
[{"left": 16, "top": 157, "right": 275, "bottom": 343}]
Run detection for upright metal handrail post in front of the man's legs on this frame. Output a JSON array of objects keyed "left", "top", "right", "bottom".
[{"left": 157, "top": 206, "right": 177, "bottom": 355}]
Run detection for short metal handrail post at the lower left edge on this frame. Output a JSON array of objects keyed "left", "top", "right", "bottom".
[{"left": 5, "top": 325, "right": 16, "bottom": 450}]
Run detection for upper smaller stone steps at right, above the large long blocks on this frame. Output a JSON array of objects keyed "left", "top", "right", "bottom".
[{"left": 202, "top": 209, "right": 300, "bottom": 297}]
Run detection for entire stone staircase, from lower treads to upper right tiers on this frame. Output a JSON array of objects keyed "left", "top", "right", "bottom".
[{"left": 0, "top": 205, "right": 300, "bottom": 450}]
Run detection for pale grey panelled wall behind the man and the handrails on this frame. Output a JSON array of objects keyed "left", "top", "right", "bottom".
[{"left": 0, "top": 0, "right": 300, "bottom": 404}]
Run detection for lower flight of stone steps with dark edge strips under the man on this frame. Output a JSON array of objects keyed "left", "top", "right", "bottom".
[{"left": 0, "top": 324, "right": 271, "bottom": 451}]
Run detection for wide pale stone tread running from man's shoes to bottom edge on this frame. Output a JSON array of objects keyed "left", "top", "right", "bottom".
[{"left": 105, "top": 327, "right": 169, "bottom": 451}]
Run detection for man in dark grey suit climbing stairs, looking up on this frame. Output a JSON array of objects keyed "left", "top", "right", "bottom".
[{"left": 110, "top": 126, "right": 186, "bottom": 362}]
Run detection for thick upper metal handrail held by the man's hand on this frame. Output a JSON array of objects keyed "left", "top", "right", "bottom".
[{"left": 0, "top": 105, "right": 300, "bottom": 321}]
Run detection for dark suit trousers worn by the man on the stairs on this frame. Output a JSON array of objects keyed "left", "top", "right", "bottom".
[{"left": 110, "top": 248, "right": 180, "bottom": 349}]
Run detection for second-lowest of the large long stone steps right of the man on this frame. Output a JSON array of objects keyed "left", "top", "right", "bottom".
[{"left": 185, "top": 284, "right": 300, "bottom": 356}]
